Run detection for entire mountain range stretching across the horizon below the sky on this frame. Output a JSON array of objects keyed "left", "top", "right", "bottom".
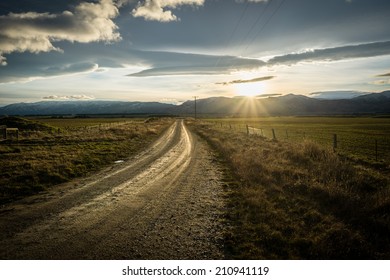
[{"left": 0, "top": 91, "right": 390, "bottom": 116}]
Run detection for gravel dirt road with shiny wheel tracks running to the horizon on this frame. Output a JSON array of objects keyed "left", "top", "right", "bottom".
[{"left": 0, "top": 120, "right": 225, "bottom": 259}]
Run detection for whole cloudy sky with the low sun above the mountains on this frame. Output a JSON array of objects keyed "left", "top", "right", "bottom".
[{"left": 0, "top": 0, "right": 390, "bottom": 106}]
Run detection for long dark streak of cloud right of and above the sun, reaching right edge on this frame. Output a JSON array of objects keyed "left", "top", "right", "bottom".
[{"left": 267, "top": 41, "right": 390, "bottom": 65}]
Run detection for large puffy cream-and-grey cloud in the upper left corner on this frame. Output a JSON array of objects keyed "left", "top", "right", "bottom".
[{"left": 0, "top": 0, "right": 121, "bottom": 66}]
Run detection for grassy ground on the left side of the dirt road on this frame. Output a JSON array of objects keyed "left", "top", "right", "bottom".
[{"left": 0, "top": 118, "right": 172, "bottom": 204}]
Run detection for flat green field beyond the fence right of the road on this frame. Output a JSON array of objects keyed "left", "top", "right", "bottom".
[{"left": 205, "top": 117, "right": 390, "bottom": 165}]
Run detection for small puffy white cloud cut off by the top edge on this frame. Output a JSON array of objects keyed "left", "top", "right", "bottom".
[{"left": 131, "top": 0, "right": 205, "bottom": 22}]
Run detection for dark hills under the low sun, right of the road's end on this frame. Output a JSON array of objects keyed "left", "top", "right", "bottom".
[{"left": 177, "top": 91, "right": 390, "bottom": 116}]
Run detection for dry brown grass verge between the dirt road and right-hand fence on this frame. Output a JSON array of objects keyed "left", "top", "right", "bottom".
[{"left": 190, "top": 121, "right": 390, "bottom": 259}]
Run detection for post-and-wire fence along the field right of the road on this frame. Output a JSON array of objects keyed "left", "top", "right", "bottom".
[{"left": 206, "top": 122, "right": 390, "bottom": 163}]
